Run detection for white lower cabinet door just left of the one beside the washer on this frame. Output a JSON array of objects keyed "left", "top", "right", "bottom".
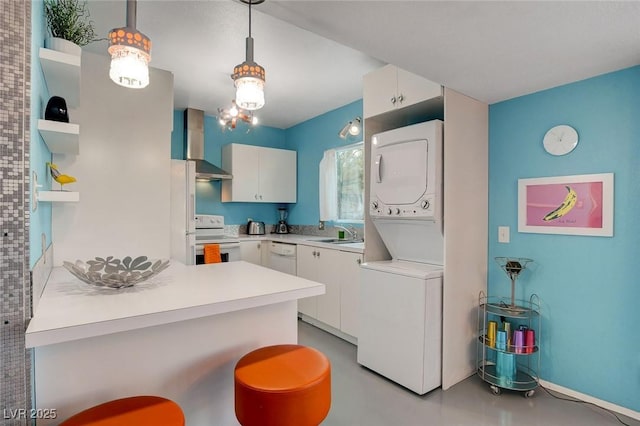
[{"left": 316, "top": 249, "right": 343, "bottom": 330}]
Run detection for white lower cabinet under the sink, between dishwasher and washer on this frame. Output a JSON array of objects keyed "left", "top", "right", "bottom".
[{"left": 297, "top": 245, "right": 362, "bottom": 337}]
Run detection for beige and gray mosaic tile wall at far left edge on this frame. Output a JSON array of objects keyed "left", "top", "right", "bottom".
[{"left": 0, "top": 1, "right": 31, "bottom": 425}]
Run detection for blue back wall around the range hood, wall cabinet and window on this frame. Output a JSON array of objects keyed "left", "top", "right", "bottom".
[{"left": 171, "top": 100, "right": 362, "bottom": 225}]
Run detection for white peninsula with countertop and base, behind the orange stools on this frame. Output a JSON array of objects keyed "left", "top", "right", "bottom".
[{"left": 26, "top": 262, "right": 325, "bottom": 426}]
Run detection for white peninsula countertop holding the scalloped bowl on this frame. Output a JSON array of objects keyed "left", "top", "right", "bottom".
[{"left": 25, "top": 261, "right": 325, "bottom": 348}]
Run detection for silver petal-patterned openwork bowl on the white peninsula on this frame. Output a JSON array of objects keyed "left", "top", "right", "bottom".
[{"left": 63, "top": 256, "right": 169, "bottom": 288}]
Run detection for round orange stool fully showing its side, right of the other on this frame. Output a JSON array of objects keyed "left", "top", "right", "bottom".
[{"left": 235, "top": 345, "right": 331, "bottom": 426}]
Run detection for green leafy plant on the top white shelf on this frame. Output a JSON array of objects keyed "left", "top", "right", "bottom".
[{"left": 44, "top": 0, "right": 100, "bottom": 46}]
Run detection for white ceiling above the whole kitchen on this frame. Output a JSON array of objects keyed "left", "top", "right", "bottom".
[{"left": 85, "top": 0, "right": 640, "bottom": 128}]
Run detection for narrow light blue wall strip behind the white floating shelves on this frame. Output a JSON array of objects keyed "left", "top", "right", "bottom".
[{"left": 29, "top": 0, "right": 51, "bottom": 269}]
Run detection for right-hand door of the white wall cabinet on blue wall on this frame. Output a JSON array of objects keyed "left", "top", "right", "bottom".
[{"left": 260, "top": 148, "right": 297, "bottom": 203}]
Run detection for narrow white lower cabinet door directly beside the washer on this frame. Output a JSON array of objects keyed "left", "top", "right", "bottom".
[{"left": 338, "top": 252, "right": 363, "bottom": 337}]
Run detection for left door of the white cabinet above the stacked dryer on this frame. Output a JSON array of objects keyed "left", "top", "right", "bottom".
[{"left": 362, "top": 65, "right": 398, "bottom": 118}]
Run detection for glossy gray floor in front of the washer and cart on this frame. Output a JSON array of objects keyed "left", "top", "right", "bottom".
[{"left": 298, "top": 321, "right": 640, "bottom": 426}]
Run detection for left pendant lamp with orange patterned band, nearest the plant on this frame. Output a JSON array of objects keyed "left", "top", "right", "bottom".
[{"left": 108, "top": 0, "right": 151, "bottom": 89}]
